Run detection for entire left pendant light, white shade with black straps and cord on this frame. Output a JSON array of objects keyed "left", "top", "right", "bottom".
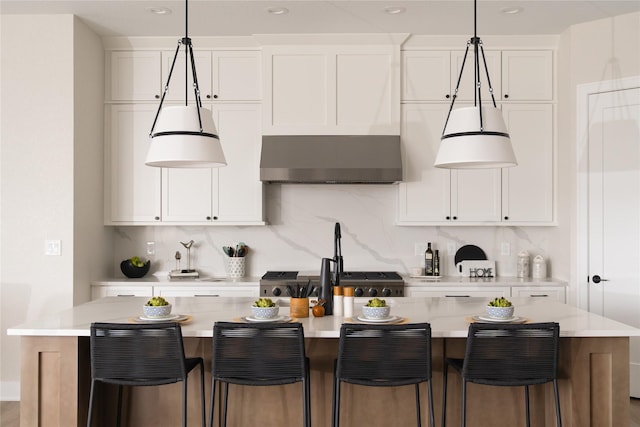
[{"left": 145, "top": 0, "right": 227, "bottom": 168}]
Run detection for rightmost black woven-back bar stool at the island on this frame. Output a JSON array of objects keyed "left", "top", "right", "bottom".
[{"left": 442, "top": 322, "right": 562, "bottom": 427}]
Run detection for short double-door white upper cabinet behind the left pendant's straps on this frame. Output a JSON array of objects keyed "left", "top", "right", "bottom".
[{"left": 162, "top": 47, "right": 262, "bottom": 102}]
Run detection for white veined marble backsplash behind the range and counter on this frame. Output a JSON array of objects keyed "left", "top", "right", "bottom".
[{"left": 113, "top": 184, "right": 554, "bottom": 277}]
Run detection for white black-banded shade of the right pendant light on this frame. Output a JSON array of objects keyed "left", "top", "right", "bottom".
[{"left": 434, "top": 106, "right": 518, "bottom": 169}]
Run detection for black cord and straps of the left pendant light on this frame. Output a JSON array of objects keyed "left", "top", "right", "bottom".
[{"left": 149, "top": 0, "right": 204, "bottom": 138}]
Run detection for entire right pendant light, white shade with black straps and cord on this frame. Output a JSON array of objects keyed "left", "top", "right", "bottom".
[{"left": 434, "top": 0, "right": 518, "bottom": 169}]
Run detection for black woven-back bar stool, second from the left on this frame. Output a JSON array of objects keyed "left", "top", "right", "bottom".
[{"left": 209, "top": 322, "right": 311, "bottom": 427}]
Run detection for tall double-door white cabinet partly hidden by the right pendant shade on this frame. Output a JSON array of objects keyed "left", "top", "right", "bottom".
[{"left": 397, "top": 104, "right": 501, "bottom": 225}]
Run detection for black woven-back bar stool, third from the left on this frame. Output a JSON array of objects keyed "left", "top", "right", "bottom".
[{"left": 332, "top": 323, "right": 435, "bottom": 427}]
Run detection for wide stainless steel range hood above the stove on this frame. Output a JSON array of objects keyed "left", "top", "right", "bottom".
[{"left": 260, "top": 135, "right": 402, "bottom": 184}]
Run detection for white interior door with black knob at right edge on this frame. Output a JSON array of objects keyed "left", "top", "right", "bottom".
[{"left": 587, "top": 88, "right": 640, "bottom": 397}]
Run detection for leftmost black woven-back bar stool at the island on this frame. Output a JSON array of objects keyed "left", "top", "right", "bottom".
[{"left": 87, "top": 322, "right": 206, "bottom": 427}]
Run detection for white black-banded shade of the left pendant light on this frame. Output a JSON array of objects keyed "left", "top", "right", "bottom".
[{"left": 145, "top": 105, "right": 227, "bottom": 168}]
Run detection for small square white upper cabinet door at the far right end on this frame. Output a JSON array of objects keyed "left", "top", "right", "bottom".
[{"left": 502, "top": 50, "right": 553, "bottom": 101}]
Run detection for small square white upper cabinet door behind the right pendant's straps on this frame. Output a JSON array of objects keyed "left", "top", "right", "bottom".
[{"left": 451, "top": 47, "right": 502, "bottom": 103}]
